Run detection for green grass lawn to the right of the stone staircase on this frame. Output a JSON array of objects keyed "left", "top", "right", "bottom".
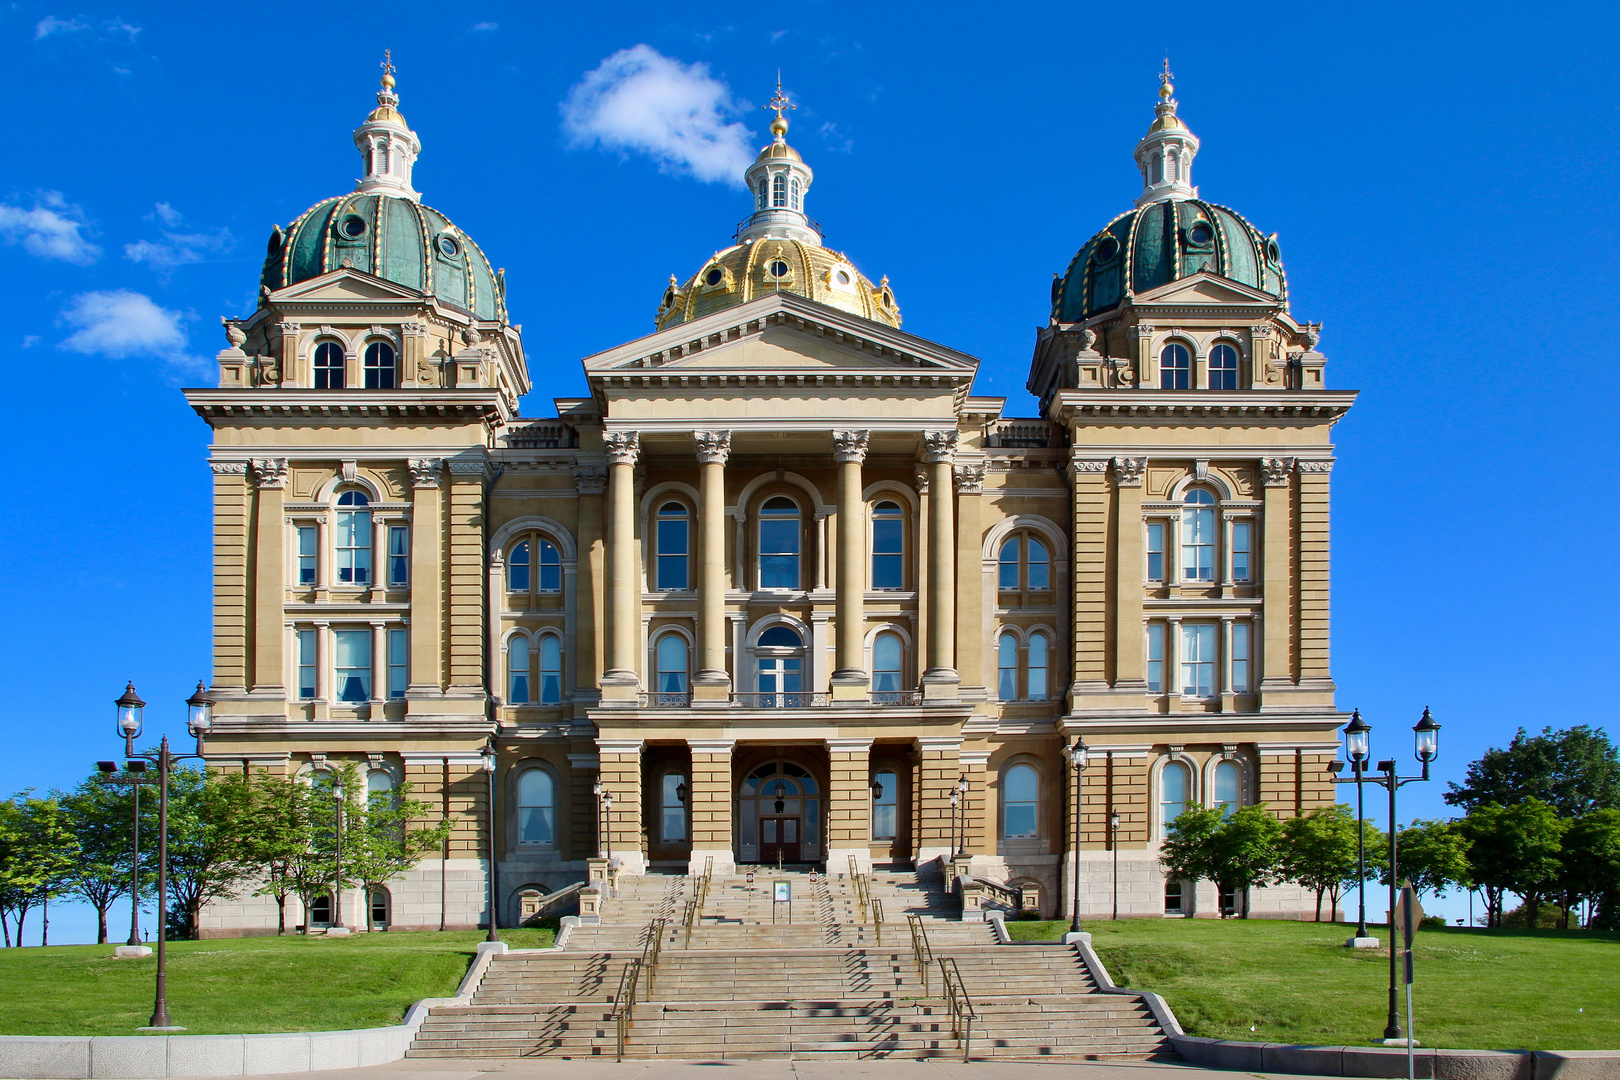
[{"left": 1004, "top": 918, "right": 1620, "bottom": 1049}]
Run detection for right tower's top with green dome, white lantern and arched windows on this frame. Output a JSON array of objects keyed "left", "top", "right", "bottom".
[{"left": 1029, "top": 62, "right": 1324, "bottom": 414}]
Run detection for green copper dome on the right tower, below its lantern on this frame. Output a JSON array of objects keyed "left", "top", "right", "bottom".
[{"left": 1051, "top": 199, "right": 1288, "bottom": 322}]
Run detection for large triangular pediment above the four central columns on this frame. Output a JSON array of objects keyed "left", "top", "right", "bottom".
[{"left": 585, "top": 293, "right": 978, "bottom": 379}]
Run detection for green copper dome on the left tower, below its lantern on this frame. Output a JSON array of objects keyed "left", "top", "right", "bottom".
[{"left": 261, "top": 193, "right": 507, "bottom": 322}]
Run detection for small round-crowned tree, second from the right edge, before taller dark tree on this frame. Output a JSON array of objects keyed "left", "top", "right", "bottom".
[{"left": 1456, "top": 798, "right": 1565, "bottom": 928}]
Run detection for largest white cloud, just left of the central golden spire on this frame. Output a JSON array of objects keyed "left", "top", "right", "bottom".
[{"left": 561, "top": 45, "right": 753, "bottom": 186}]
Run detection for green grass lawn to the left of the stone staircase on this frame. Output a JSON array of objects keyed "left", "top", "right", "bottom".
[{"left": 0, "top": 929, "right": 552, "bottom": 1035}]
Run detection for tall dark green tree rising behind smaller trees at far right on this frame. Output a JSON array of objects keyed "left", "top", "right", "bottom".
[{"left": 1445, "top": 724, "right": 1620, "bottom": 818}]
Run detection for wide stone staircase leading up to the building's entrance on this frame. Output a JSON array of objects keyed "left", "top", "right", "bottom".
[{"left": 407, "top": 871, "right": 1173, "bottom": 1061}]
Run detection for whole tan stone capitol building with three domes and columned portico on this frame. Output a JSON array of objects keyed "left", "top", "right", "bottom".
[{"left": 186, "top": 63, "right": 1356, "bottom": 936}]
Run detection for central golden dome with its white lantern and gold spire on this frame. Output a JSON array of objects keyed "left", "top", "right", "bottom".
[{"left": 654, "top": 83, "right": 901, "bottom": 330}]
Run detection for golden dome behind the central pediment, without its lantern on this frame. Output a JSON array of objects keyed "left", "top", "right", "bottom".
[{"left": 656, "top": 238, "right": 901, "bottom": 330}]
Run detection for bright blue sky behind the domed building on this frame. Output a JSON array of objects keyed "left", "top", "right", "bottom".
[{"left": 0, "top": 0, "right": 1620, "bottom": 941}]
